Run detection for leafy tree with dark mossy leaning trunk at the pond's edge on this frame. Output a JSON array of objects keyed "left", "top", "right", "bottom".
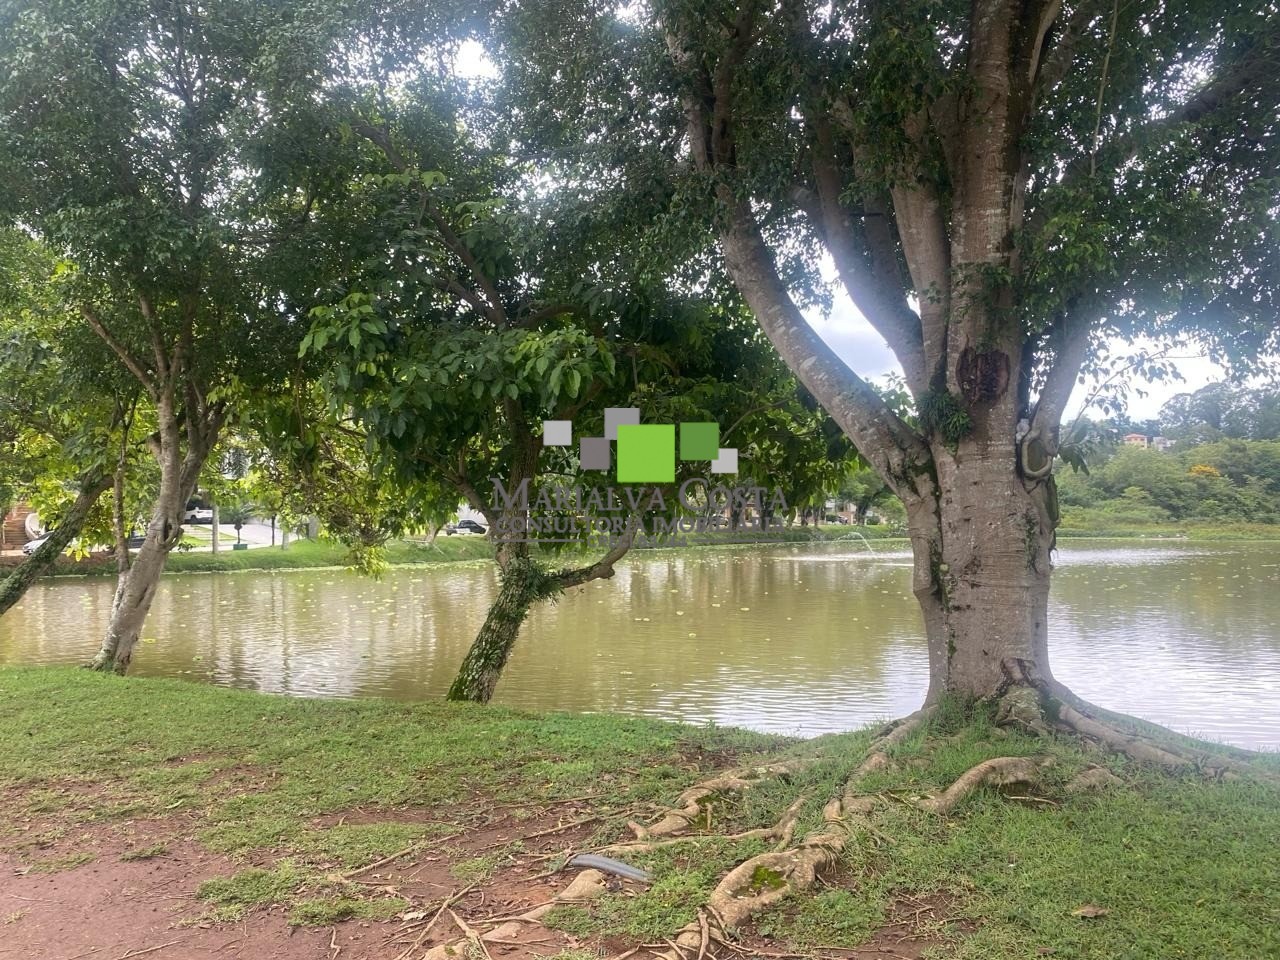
[{"left": 291, "top": 26, "right": 849, "bottom": 701}]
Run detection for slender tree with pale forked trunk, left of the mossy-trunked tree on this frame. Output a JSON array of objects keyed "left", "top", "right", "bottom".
[{"left": 0, "top": 0, "right": 340, "bottom": 672}]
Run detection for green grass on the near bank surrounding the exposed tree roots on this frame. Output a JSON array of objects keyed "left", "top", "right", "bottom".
[{"left": 0, "top": 668, "right": 1280, "bottom": 960}]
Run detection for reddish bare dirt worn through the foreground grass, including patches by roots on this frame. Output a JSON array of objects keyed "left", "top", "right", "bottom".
[{"left": 0, "top": 829, "right": 940, "bottom": 960}]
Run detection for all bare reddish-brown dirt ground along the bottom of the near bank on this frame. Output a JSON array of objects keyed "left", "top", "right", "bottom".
[{"left": 0, "top": 806, "right": 945, "bottom": 960}]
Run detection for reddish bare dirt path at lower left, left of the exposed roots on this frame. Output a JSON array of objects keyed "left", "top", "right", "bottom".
[{"left": 0, "top": 819, "right": 609, "bottom": 960}]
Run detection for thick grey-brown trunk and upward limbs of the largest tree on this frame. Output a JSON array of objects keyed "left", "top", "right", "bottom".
[{"left": 667, "top": 0, "right": 1080, "bottom": 701}]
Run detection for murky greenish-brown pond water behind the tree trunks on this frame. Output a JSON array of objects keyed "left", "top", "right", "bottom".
[{"left": 0, "top": 544, "right": 1280, "bottom": 749}]
